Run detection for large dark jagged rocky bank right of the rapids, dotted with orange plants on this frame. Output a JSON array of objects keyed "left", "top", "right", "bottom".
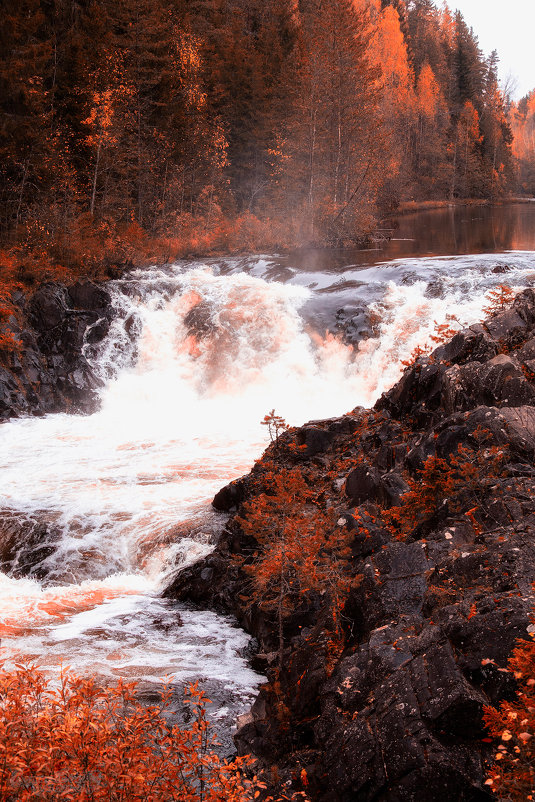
[{"left": 167, "top": 290, "right": 535, "bottom": 802}]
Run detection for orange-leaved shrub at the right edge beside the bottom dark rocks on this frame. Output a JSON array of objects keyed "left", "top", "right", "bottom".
[{"left": 484, "top": 628, "right": 535, "bottom": 802}]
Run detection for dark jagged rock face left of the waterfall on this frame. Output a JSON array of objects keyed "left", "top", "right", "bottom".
[{"left": 0, "top": 281, "right": 113, "bottom": 420}]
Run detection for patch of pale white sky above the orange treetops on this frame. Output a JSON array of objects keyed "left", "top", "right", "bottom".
[{"left": 452, "top": 0, "right": 535, "bottom": 100}]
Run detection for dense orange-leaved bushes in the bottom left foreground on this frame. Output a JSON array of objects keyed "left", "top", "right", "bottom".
[{"left": 0, "top": 666, "right": 254, "bottom": 802}]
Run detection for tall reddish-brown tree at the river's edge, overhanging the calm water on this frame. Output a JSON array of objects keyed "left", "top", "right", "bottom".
[{"left": 272, "top": 0, "right": 381, "bottom": 241}]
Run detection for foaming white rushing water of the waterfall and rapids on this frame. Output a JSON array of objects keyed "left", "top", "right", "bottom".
[{"left": 0, "top": 208, "right": 535, "bottom": 732}]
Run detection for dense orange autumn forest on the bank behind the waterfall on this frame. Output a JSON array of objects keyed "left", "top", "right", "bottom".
[{"left": 0, "top": 0, "right": 520, "bottom": 265}]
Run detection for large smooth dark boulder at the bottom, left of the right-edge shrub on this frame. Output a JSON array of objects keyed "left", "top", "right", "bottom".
[{"left": 315, "top": 618, "right": 487, "bottom": 802}]
